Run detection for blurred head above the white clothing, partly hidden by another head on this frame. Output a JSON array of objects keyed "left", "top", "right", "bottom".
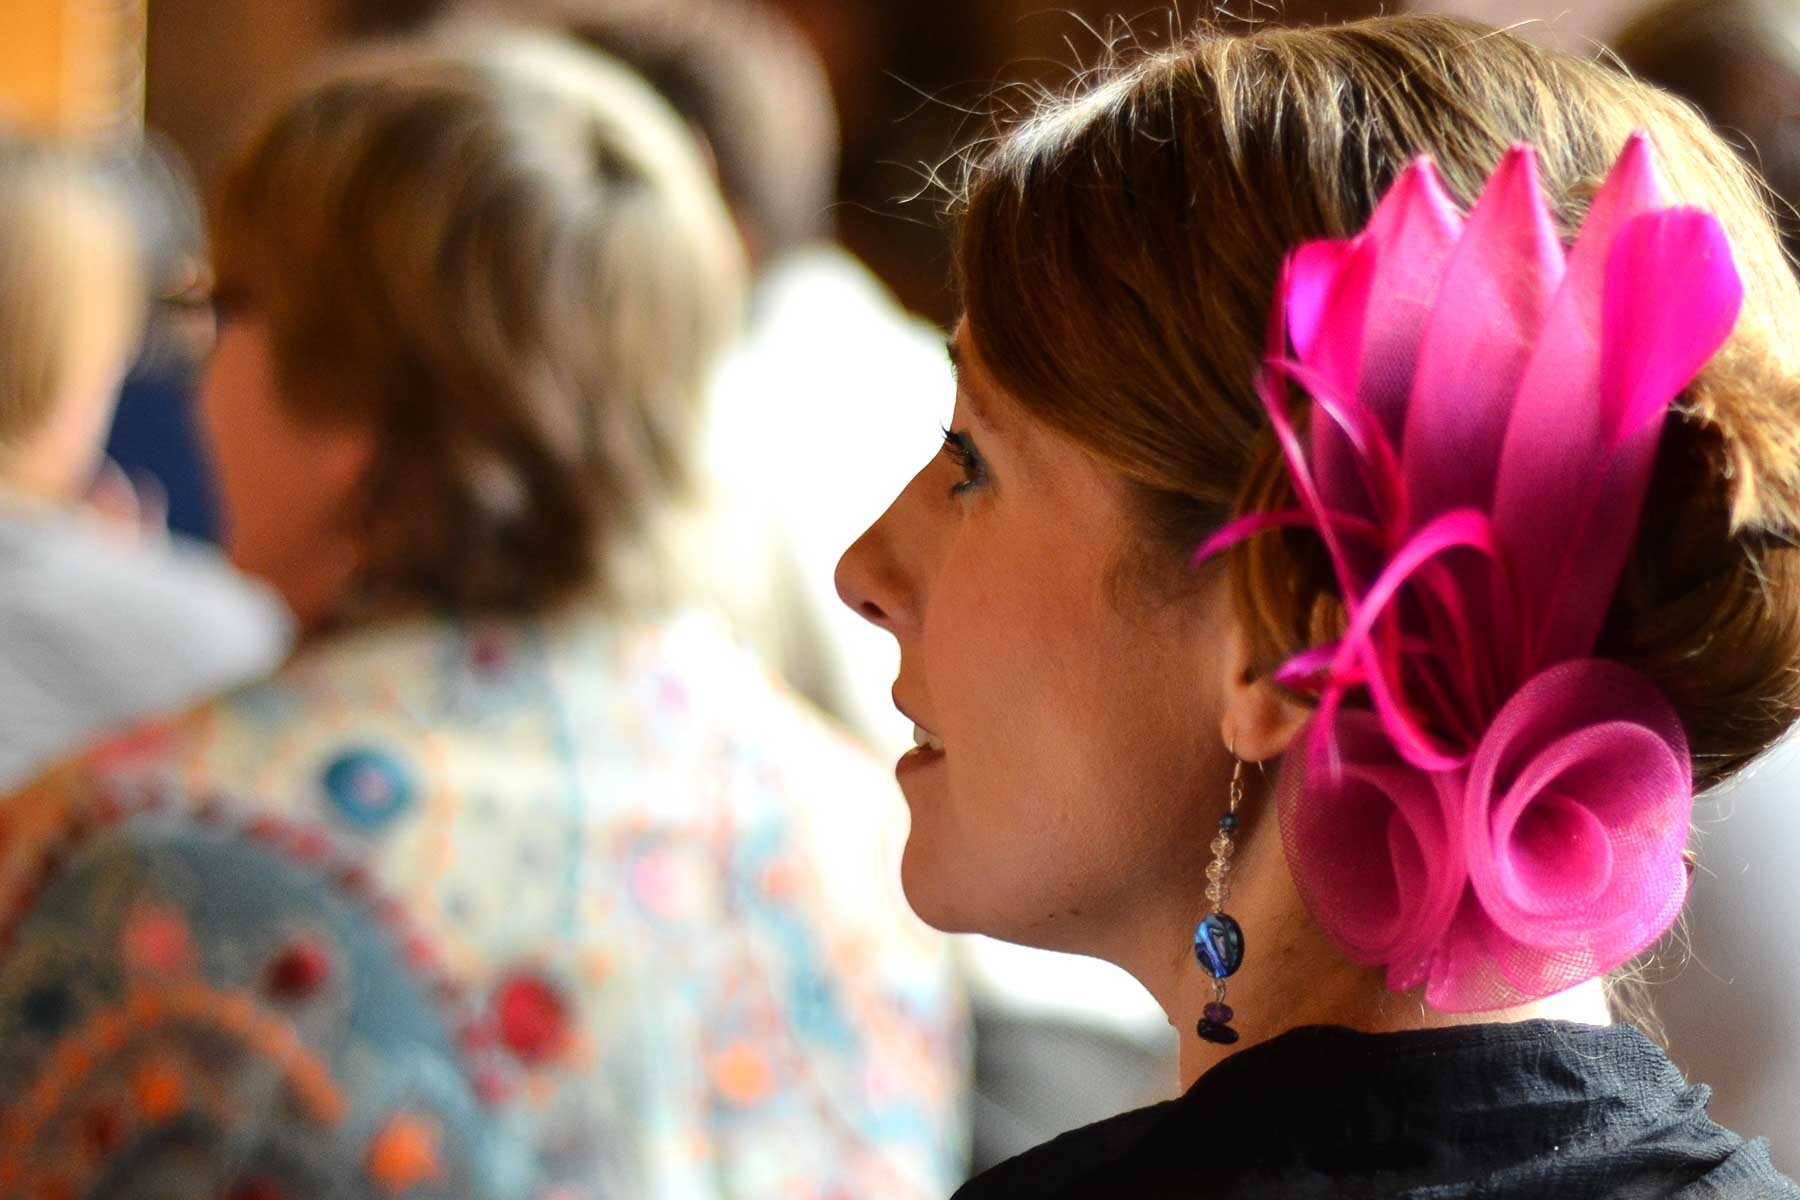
[{"left": 466, "top": 0, "right": 839, "bottom": 264}]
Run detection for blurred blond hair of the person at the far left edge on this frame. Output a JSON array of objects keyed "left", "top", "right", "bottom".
[{"left": 0, "top": 131, "right": 146, "bottom": 470}]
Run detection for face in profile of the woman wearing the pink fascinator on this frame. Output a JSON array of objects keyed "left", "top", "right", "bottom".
[{"left": 837, "top": 324, "right": 1231, "bottom": 952}]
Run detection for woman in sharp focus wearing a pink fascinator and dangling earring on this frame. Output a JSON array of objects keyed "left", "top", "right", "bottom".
[{"left": 839, "top": 18, "right": 1800, "bottom": 1198}]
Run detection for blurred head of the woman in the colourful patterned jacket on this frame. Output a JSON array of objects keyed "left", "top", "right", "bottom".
[{"left": 202, "top": 31, "right": 743, "bottom": 626}]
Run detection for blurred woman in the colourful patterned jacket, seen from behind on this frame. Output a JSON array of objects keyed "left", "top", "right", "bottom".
[{"left": 0, "top": 32, "right": 959, "bottom": 1198}]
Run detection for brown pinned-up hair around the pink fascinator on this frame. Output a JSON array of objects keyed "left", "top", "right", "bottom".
[{"left": 958, "top": 16, "right": 1800, "bottom": 798}]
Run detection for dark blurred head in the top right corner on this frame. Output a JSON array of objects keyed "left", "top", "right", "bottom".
[{"left": 1613, "top": 0, "right": 1800, "bottom": 261}]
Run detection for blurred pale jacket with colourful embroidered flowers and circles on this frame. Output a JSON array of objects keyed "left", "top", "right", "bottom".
[{"left": 0, "top": 613, "right": 965, "bottom": 1200}]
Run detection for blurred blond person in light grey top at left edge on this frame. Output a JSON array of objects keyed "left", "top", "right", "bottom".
[{"left": 0, "top": 133, "right": 288, "bottom": 786}]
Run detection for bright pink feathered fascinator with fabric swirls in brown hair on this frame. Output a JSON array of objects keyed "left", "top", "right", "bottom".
[{"left": 1195, "top": 133, "right": 1742, "bottom": 1011}]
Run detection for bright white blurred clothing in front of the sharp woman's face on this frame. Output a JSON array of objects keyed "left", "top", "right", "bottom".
[{"left": 706, "top": 245, "right": 956, "bottom": 756}]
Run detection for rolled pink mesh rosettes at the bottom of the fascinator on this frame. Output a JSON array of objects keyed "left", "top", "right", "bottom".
[{"left": 1278, "top": 658, "right": 1692, "bottom": 1011}]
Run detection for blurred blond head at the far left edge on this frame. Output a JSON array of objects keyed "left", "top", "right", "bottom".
[{"left": 0, "top": 133, "right": 146, "bottom": 504}]
